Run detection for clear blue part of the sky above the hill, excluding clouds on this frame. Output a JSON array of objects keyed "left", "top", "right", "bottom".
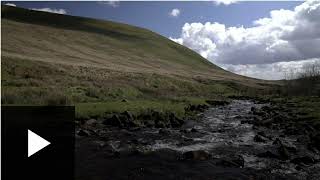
[{"left": 3, "top": 2, "right": 300, "bottom": 37}]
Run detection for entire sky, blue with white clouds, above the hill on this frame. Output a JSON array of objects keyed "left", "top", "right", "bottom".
[{"left": 2, "top": 0, "right": 320, "bottom": 79}]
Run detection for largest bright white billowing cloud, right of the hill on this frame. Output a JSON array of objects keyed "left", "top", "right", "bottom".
[{"left": 172, "top": 1, "right": 320, "bottom": 78}]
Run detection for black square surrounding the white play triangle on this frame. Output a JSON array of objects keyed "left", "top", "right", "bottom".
[{"left": 1, "top": 106, "right": 75, "bottom": 180}]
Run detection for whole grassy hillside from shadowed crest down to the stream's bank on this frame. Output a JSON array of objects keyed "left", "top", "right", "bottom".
[{"left": 1, "top": 6, "right": 275, "bottom": 119}]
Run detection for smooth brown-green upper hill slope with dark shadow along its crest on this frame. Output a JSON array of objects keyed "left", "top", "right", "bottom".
[{"left": 2, "top": 6, "right": 262, "bottom": 81}]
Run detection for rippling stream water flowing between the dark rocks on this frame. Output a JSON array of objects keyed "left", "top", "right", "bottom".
[{"left": 78, "top": 100, "right": 319, "bottom": 179}]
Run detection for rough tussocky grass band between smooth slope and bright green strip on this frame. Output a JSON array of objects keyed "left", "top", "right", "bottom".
[{"left": 1, "top": 57, "right": 240, "bottom": 104}]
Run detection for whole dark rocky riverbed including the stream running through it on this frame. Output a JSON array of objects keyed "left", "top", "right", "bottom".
[{"left": 76, "top": 100, "right": 320, "bottom": 180}]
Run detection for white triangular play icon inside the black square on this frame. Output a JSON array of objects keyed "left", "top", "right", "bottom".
[{"left": 28, "top": 129, "right": 50, "bottom": 157}]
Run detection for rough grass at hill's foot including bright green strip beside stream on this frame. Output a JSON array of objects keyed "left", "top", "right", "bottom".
[{"left": 1, "top": 57, "right": 222, "bottom": 119}]
